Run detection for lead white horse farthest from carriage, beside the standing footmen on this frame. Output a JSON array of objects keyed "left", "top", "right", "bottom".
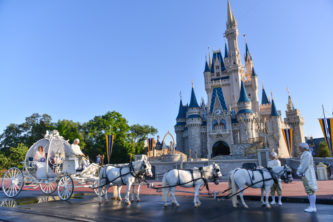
[{"left": 229, "top": 165, "right": 293, "bottom": 208}]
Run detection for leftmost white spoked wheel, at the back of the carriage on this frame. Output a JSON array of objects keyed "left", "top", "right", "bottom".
[{"left": 2, "top": 167, "right": 24, "bottom": 197}]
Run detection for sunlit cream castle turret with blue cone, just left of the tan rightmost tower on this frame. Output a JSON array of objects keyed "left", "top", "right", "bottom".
[{"left": 267, "top": 98, "right": 290, "bottom": 158}]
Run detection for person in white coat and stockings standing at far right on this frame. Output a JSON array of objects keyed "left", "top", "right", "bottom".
[{"left": 297, "top": 143, "right": 318, "bottom": 213}]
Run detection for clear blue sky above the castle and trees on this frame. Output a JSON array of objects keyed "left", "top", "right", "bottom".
[{"left": 0, "top": 0, "right": 333, "bottom": 137}]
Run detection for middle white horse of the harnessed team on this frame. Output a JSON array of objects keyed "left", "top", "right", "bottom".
[{"left": 162, "top": 163, "right": 222, "bottom": 207}]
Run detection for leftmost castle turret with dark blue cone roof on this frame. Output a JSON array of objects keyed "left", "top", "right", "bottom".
[{"left": 175, "top": 98, "right": 187, "bottom": 152}]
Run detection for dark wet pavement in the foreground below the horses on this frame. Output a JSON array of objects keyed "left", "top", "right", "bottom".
[{"left": 0, "top": 191, "right": 333, "bottom": 222}]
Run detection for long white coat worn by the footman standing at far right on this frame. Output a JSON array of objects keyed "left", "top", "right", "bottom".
[{"left": 297, "top": 151, "right": 318, "bottom": 192}]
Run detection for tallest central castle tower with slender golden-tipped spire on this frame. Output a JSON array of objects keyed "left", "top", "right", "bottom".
[{"left": 223, "top": 0, "right": 244, "bottom": 110}]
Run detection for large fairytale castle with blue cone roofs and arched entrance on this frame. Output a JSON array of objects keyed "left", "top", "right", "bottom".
[{"left": 175, "top": 0, "right": 305, "bottom": 158}]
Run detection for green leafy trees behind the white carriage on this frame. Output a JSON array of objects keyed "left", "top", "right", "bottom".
[{"left": 0, "top": 111, "right": 157, "bottom": 168}]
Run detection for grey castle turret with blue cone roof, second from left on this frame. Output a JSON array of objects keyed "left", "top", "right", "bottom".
[{"left": 184, "top": 85, "right": 202, "bottom": 157}]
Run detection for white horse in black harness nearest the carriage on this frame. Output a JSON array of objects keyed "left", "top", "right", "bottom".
[{"left": 98, "top": 158, "right": 152, "bottom": 205}]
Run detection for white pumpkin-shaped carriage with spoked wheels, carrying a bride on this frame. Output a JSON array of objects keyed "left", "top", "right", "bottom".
[{"left": 2, "top": 130, "right": 99, "bottom": 200}]
